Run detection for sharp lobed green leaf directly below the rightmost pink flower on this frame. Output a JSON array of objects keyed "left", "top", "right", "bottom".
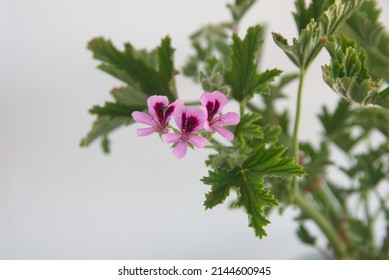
[{"left": 202, "top": 141, "right": 305, "bottom": 238}]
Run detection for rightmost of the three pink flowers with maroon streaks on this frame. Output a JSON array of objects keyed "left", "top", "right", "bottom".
[{"left": 200, "top": 91, "right": 240, "bottom": 141}]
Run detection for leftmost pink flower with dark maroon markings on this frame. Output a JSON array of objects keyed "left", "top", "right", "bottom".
[{"left": 131, "top": 95, "right": 182, "bottom": 136}]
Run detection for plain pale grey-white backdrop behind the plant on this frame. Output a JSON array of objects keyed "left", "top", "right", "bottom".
[{"left": 0, "top": 0, "right": 389, "bottom": 259}]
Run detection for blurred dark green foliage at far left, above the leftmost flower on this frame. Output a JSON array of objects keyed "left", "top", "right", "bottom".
[{"left": 80, "top": 37, "right": 177, "bottom": 152}]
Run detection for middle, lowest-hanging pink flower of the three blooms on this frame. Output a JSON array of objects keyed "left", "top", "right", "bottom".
[{"left": 162, "top": 106, "right": 208, "bottom": 158}]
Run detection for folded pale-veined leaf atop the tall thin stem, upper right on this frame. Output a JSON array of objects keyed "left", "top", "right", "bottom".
[{"left": 273, "top": 0, "right": 364, "bottom": 70}]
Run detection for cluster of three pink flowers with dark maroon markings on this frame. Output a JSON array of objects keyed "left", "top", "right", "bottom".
[{"left": 132, "top": 91, "right": 240, "bottom": 158}]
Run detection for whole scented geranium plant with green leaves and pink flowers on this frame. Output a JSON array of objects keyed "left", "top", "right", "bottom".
[{"left": 81, "top": 0, "right": 389, "bottom": 259}]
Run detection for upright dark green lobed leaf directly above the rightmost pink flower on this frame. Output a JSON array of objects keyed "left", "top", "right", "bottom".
[{"left": 225, "top": 25, "right": 282, "bottom": 102}]
